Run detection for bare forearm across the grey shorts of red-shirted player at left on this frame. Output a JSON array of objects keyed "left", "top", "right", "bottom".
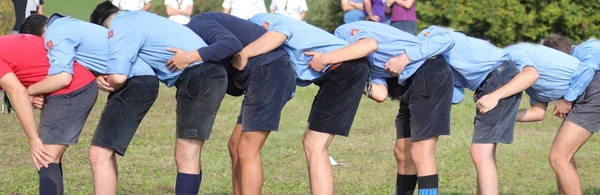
[{"left": 27, "top": 72, "right": 73, "bottom": 95}]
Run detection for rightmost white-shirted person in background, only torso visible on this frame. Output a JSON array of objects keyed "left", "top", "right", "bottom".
[{"left": 269, "top": 0, "right": 308, "bottom": 21}]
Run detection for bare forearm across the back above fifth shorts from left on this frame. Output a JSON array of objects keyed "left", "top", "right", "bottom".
[{"left": 323, "top": 38, "right": 378, "bottom": 64}]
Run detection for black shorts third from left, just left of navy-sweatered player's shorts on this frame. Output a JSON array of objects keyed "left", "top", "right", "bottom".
[{"left": 175, "top": 62, "right": 227, "bottom": 140}]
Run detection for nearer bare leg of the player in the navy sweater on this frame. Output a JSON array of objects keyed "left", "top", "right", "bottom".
[{"left": 238, "top": 131, "right": 271, "bottom": 195}]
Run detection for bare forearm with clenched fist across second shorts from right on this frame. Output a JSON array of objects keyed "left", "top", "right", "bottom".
[{"left": 492, "top": 66, "right": 539, "bottom": 99}]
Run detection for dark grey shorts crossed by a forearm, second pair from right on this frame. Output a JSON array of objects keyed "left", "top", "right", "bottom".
[{"left": 472, "top": 60, "right": 521, "bottom": 144}]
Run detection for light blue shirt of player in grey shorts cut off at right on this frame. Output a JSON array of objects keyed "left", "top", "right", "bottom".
[{"left": 505, "top": 43, "right": 596, "bottom": 104}]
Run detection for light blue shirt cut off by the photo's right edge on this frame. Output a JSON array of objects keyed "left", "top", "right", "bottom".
[{"left": 572, "top": 39, "right": 600, "bottom": 70}]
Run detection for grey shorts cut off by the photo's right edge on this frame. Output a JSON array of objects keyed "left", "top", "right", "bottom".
[{"left": 566, "top": 73, "right": 600, "bottom": 133}]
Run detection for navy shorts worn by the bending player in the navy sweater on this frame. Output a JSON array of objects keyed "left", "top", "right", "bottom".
[{"left": 237, "top": 55, "right": 296, "bottom": 131}]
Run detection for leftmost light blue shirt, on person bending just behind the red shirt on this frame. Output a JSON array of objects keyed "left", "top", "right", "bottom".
[{"left": 44, "top": 16, "right": 154, "bottom": 77}]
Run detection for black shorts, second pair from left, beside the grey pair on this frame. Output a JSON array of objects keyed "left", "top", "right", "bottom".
[{"left": 91, "top": 76, "right": 158, "bottom": 156}]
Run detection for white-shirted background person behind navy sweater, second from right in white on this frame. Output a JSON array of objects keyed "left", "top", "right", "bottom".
[{"left": 223, "top": 0, "right": 267, "bottom": 20}]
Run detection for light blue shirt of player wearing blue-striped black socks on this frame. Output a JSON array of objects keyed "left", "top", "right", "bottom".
[{"left": 334, "top": 21, "right": 427, "bottom": 84}]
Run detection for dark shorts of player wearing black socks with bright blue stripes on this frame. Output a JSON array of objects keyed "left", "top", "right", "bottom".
[{"left": 396, "top": 55, "right": 454, "bottom": 141}]
